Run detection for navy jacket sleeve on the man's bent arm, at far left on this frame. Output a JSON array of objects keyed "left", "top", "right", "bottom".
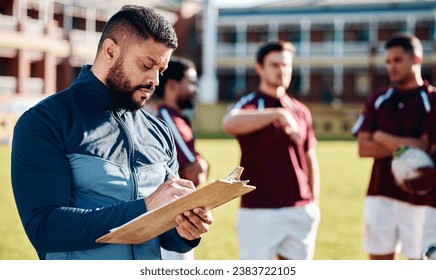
[{"left": 11, "top": 109, "right": 146, "bottom": 254}]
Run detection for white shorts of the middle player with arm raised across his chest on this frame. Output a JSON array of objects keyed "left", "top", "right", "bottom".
[{"left": 237, "top": 203, "right": 320, "bottom": 260}]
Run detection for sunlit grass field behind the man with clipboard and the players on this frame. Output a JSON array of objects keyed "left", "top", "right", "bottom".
[{"left": 0, "top": 139, "right": 371, "bottom": 260}]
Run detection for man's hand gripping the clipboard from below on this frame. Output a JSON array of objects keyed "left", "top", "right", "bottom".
[{"left": 176, "top": 208, "right": 213, "bottom": 240}]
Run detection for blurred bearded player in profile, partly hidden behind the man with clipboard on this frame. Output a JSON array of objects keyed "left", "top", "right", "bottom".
[{"left": 155, "top": 57, "right": 209, "bottom": 260}]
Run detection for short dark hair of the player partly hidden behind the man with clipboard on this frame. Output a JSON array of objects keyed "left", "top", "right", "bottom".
[{"left": 153, "top": 56, "right": 196, "bottom": 98}]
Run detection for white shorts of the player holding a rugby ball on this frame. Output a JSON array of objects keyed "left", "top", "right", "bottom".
[{"left": 363, "top": 196, "right": 426, "bottom": 259}]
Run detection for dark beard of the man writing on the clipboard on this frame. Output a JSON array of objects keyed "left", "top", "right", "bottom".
[{"left": 105, "top": 57, "right": 154, "bottom": 111}]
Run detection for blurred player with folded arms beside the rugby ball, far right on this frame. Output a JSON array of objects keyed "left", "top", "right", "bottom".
[{"left": 353, "top": 34, "right": 436, "bottom": 260}]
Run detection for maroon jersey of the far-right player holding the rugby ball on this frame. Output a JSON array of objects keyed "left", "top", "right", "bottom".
[{"left": 357, "top": 82, "right": 436, "bottom": 207}]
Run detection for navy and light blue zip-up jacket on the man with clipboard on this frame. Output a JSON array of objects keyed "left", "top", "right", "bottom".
[{"left": 11, "top": 66, "right": 200, "bottom": 259}]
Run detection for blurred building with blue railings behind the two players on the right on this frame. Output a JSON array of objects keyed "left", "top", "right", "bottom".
[{"left": 189, "top": 0, "right": 436, "bottom": 135}]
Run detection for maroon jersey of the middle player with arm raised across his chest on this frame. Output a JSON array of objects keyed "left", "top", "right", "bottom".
[{"left": 232, "top": 91, "right": 316, "bottom": 208}]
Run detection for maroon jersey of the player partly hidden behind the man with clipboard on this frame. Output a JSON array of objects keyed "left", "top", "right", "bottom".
[{"left": 157, "top": 105, "right": 201, "bottom": 168}]
